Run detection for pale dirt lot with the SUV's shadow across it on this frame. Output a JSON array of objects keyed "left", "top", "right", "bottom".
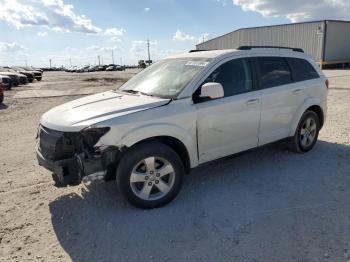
[{"left": 0, "top": 70, "right": 350, "bottom": 262}]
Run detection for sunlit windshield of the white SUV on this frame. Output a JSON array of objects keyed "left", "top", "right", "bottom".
[{"left": 119, "top": 58, "right": 210, "bottom": 98}]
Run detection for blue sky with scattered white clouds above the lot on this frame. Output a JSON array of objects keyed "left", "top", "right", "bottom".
[{"left": 0, "top": 0, "right": 350, "bottom": 67}]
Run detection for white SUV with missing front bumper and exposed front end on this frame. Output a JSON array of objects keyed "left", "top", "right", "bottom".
[{"left": 37, "top": 47, "right": 328, "bottom": 208}]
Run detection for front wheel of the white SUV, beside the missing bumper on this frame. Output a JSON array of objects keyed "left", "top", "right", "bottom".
[{"left": 116, "top": 141, "right": 185, "bottom": 209}]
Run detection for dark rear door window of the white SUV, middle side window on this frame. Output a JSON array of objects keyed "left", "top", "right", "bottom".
[{"left": 259, "top": 57, "right": 292, "bottom": 88}]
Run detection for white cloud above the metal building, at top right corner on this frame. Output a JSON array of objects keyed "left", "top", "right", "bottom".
[{"left": 233, "top": 0, "right": 350, "bottom": 22}]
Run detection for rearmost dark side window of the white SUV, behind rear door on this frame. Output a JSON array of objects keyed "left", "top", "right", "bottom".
[{"left": 287, "top": 58, "right": 319, "bottom": 82}]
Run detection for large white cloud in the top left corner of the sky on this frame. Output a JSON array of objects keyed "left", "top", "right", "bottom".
[{"left": 0, "top": 0, "right": 102, "bottom": 34}]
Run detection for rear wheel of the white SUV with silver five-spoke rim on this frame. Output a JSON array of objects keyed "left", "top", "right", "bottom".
[{"left": 289, "top": 111, "right": 320, "bottom": 153}]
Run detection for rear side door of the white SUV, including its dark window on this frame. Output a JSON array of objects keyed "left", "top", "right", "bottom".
[{"left": 257, "top": 56, "right": 305, "bottom": 145}]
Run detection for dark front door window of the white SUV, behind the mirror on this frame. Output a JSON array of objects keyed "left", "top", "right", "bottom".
[{"left": 205, "top": 59, "right": 253, "bottom": 97}]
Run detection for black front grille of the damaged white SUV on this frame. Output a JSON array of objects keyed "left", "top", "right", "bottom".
[{"left": 39, "top": 126, "right": 80, "bottom": 161}]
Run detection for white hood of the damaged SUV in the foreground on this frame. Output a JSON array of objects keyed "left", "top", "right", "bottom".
[{"left": 40, "top": 91, "right": 170, "bottom": 132}]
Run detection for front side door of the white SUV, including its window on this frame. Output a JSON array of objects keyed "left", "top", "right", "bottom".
[{"left": 194, "top": 59, "right": 260, "bottom": 163}]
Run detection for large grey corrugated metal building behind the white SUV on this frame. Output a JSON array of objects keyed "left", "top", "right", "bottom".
[{"left": 196, "top": 20, "right": 350, "bottom": 67}]
